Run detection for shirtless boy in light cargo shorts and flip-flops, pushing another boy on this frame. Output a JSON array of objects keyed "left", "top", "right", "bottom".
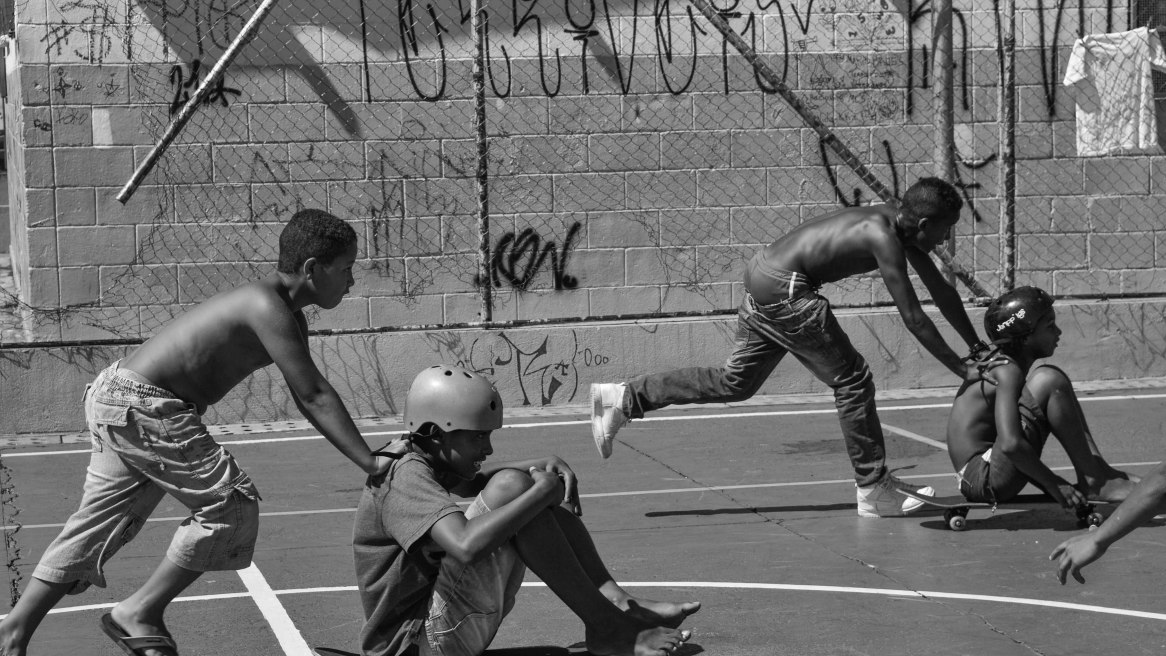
[{"left": 0, "top": 210, "right": 391, "bottom": 656}]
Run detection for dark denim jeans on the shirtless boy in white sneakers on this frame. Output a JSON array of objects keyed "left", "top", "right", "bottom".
[{"left": 627, "top": 266, "right": 886, "bottom": 486}]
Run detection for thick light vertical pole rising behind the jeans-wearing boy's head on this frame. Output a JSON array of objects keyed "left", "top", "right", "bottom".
[{"left": 932, "top": 0, "right": 955, "bottom": 284}]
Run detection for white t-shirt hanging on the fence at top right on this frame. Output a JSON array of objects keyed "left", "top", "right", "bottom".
[{"left": 1065, "top": 27, "right": 1166, "bottom": 156}]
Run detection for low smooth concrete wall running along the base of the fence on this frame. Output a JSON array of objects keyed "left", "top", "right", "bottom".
[{"left": 0, "top": 301, "right": 1166, "bottom": 439}]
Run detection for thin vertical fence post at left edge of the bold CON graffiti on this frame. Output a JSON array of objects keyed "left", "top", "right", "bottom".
[{"left": 470, "top": 0, "right": 494, "bottom": 323}]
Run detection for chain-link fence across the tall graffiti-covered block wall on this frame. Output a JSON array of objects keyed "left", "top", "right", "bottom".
[{"left": 6, "top": 0, "right": 1166, "bottom": 341}]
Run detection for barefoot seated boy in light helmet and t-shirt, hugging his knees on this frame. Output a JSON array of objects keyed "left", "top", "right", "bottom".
[{"left": 352, "top": 365, "right": 700, "bottom": 656}]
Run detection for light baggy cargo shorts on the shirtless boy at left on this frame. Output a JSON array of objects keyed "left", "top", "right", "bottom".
[{"left": 33, "top": 362, "right": 259, "bottom": 594}]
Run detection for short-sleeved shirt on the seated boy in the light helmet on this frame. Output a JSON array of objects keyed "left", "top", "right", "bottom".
[{"left": 352, "top": 453, "right": 461, "bottom": 656}]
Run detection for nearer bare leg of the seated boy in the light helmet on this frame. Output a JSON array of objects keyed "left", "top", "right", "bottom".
[{"left": 482, "top": 470, "right": 687, "bottom": 656}]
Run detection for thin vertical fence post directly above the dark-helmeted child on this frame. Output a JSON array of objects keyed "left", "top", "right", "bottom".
[{"left": 999, "top": 0, "right": 1017, "bottom": 291}]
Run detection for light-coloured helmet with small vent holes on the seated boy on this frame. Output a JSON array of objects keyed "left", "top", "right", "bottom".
[{"left": 405, "top": 365, "right": 503, "bottom": 432}]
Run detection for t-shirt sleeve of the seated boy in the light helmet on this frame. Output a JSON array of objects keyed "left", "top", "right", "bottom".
[{"left": 381, "top": 458, "right": 461, "bottom": 551}]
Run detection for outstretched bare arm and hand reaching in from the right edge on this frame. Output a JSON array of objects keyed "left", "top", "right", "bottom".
[{"left": 1048, "top": 463, "right": 1166, "bottom": 585}]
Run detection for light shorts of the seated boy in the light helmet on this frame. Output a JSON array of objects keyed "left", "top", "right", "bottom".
[{"left": 419, "top": 495, "right": 526, "bottom": 656}]
